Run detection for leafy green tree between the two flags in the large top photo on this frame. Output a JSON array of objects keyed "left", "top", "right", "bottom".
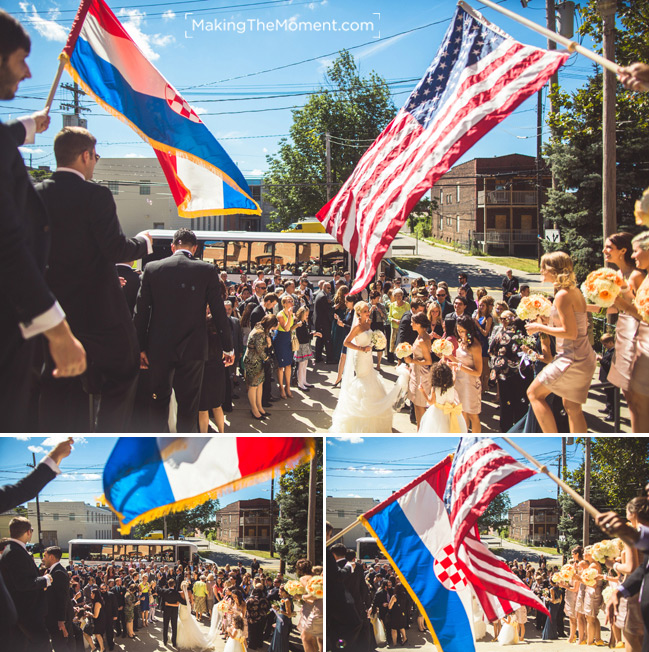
[{"left": 264, "top": 50, "right": 396, "bottom": 231}]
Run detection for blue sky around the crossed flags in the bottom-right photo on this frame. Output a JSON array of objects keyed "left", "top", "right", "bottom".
[{"left": 326, "top": 437, "right": 583, "bottom": 505}]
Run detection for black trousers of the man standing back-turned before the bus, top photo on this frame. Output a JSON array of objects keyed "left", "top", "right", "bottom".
[{"left": 149, "top": 359, "right": 205, "bottom": 432}]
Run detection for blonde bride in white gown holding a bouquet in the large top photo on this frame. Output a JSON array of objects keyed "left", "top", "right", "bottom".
[{"left": 330, "top": 301, "right": 410, "bottom": 433}]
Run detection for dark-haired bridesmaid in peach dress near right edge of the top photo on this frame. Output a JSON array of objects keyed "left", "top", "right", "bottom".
[{"left": 603, "top": 232, "right": 646, "bottom": 432}]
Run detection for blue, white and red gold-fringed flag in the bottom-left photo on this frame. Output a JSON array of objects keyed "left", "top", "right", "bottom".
[{"left": 103, "top": 437, "right": 315, "bottom": 534}]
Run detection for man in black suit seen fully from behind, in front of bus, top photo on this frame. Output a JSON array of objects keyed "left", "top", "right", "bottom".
[{"left": 134, "top": 229, "right": 234, "bottom": 432}]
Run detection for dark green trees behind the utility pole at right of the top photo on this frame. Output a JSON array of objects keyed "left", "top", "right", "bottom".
[{"left": 542, "top": 0, "right": 649, "bottom": 281}]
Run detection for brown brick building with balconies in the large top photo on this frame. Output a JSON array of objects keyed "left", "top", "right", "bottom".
[{"left": 431, "top": 154, "right": 551, "bottom": 255}]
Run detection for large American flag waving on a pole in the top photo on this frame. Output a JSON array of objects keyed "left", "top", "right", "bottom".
[{"left": 317, "top": 1, "right": 569, "bottom": 293}]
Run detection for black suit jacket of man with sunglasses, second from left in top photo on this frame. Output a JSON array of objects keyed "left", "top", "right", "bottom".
[{"left": 36, "top": 172, "right": 147, "bottom": 336}]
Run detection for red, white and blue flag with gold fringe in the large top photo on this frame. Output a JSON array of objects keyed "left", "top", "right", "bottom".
[{"left": 60, "top": 0, "right": 261, "bottom": 217}]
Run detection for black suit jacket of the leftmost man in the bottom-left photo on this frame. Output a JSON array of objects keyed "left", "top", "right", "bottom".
[{"left": 0, "top": 541, "right": 47, "bottom": 631}]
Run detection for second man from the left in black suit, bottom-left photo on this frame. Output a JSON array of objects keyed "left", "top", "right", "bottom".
[{"left": 43, "top": 546, "right": 74, "bottom": 652}]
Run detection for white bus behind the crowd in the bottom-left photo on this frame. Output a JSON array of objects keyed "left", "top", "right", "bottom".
[{"left": 68, "top": 539, "right": 198, "bottom": 565}]
